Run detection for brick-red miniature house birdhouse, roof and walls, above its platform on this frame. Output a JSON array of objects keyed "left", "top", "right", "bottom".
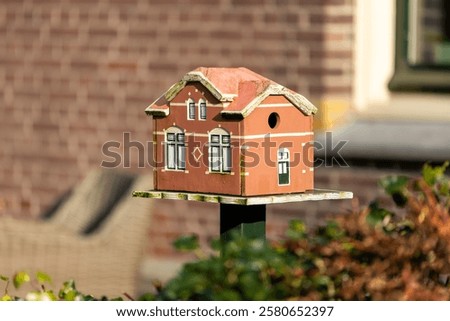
[{"left": 146, "top": 67, "right": 317, "bottom": 196}]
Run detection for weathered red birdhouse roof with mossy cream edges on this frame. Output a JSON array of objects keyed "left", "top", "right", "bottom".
[{"left": 145, "top": 67, "right": 317, "bottom": 118}]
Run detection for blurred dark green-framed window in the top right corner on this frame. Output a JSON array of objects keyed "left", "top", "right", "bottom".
[{"left": 389, "top": 0, "right": 450, "bottom": 92}]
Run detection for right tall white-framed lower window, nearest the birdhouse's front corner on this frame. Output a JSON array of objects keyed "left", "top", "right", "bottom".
[{"left": 209, "top": 128, "right": 231, "bottom": 173}]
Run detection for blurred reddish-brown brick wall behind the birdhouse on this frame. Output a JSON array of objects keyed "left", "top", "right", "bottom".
[{"left": 0, "top": 0, "right": 358, "bottom": 254}]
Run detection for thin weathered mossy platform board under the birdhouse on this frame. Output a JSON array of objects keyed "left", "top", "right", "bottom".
[{"left": 133, "top": 189, "right": 353, "bottom": 205}]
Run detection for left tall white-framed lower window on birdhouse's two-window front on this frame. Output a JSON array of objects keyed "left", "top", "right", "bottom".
[{"left": 165, "top": 127, "right": 186, "bottom": 170}]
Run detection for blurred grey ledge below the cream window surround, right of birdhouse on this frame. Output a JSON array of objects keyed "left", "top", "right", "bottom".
[{"left": 315, "top": 119, "right": 450, "bottom": 161}]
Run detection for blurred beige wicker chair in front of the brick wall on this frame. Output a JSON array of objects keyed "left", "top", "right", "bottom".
[{"left": 0, "top": 170, "right": 152, "bottom": 296}]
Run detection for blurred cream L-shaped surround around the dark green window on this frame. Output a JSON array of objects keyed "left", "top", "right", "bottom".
[{"left": 352, "top": 0, "right": 450, "bottom": 121}]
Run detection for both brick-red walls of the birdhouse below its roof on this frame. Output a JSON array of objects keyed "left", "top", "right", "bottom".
[{"left": 153, "top": 82, "right": 314, "bottom": 196}]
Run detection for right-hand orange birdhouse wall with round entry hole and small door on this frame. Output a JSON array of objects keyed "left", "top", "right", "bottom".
[{"left": 241, "top": 96, "right": 314, "bottom": 196}]
